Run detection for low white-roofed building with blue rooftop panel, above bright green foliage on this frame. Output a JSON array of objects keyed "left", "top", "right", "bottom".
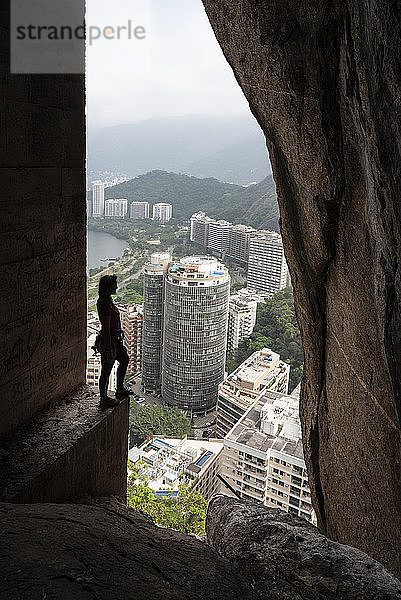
[{"left": 128, "top": 435, "right": 223, "bottom": 500}]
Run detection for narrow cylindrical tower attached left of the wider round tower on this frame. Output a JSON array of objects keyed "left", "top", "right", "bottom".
[{"left": 142, "top": 253, "right": 171, "bottom": 392}]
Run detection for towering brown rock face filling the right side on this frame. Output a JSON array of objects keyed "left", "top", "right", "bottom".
[{"left": 203, "top": 0, "right": 401, "bottom": 576}]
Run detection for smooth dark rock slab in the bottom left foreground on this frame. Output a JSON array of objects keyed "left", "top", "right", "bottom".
[{"left": 0, "top": 503, "right": 254, "bottom": 600}]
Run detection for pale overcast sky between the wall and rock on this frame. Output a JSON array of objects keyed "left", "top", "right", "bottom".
[{"left": 87, "top": 0, "right": 249, "bottom": 128}]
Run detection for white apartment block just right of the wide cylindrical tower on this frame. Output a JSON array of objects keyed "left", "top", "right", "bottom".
[{"left": 227, "top": 292, "right": 258, "bottom": 352}]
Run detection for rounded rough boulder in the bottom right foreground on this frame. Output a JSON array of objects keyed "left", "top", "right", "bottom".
[{"left": 207, "top": 496, "right": 401, "bottom": 600}]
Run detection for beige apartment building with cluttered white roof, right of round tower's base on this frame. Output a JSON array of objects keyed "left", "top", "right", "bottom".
[{"left": 216, "top": 348, "right": 290, "bottom": 437}]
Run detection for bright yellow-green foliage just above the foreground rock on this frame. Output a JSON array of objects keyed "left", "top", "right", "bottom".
[{"left": 127, "top": 463, "right": 206, "bottom": 535}]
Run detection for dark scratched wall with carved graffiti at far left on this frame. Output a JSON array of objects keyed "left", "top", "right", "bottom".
[{"left": 0, "top": 0, "right": 86, "bottom": 437}]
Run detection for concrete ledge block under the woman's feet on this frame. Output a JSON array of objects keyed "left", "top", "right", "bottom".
[{"left": 0, "top": 386, "right": 129, "bottom": 503}]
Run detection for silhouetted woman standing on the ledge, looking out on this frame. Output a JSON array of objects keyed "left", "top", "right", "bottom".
[{"left": 97, "top": 275, "right": 129, "bottom": 407}]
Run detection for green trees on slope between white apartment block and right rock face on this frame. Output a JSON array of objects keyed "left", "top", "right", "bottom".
[{"left": 227, "top": 288, "right": 304, "bottom": 392}]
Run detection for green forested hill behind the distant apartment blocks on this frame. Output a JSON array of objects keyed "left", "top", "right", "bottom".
[{"left": 95, "top": 171, "right": 278, "bottom": 230}]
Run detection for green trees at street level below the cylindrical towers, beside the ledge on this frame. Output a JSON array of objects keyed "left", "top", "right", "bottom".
[{"left": 130, "top": 402, "right": 191, "bottom": 446}]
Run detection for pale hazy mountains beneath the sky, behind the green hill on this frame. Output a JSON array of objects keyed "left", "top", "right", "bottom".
[{"left": 88, "top": 115, "right": 271, "bottom": 185}]
